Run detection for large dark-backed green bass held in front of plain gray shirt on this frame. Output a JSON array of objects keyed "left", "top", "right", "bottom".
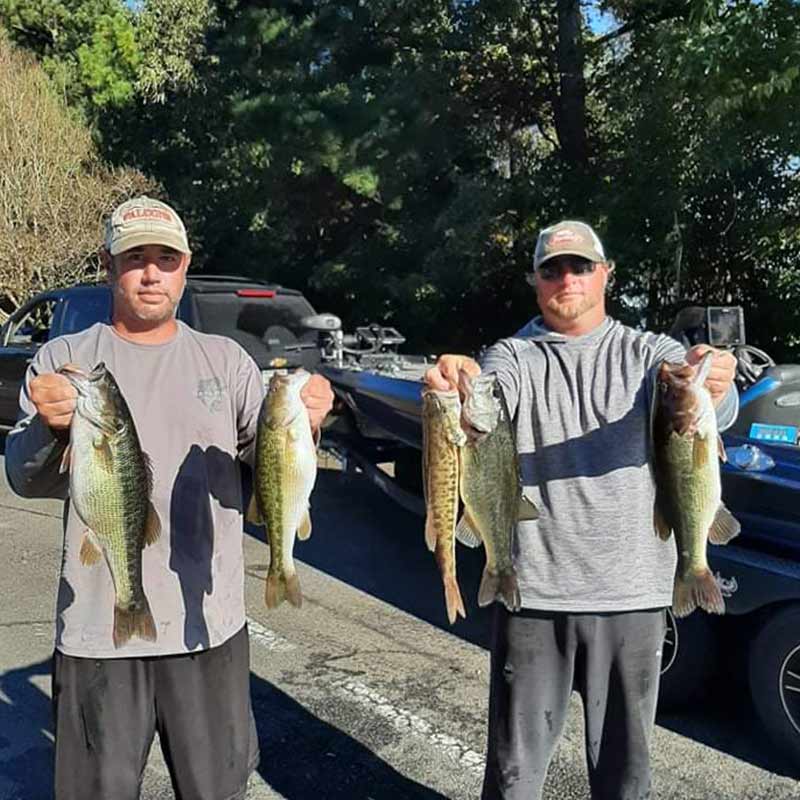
[{"left": 58, "top": 363, "right": 161, "bottom": 647}]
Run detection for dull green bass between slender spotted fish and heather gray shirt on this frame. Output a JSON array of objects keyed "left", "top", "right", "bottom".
[{"left": 456, "top": 370, "right": 539, "bottom": 611}]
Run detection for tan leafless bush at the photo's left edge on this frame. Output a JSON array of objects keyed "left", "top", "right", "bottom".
[{"left": 0, "top": 30, "right": 155, "bottom": 312}]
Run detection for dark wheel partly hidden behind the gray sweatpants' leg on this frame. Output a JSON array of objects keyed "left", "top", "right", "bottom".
[{"left": 658, "top": 609, "right": 719, "bottom": 711}]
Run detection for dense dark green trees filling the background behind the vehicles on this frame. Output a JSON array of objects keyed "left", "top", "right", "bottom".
[{"left": 0, "top": 0, "right": 800, "bottom": 358}]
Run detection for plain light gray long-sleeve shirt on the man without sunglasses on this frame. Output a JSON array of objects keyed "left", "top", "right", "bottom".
[{"left": 6, "top": 322, "right": 264, "bottom": 658}]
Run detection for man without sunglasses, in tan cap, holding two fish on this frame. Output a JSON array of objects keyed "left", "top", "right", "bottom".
[{"left": 6, "top": 197, "right": 333, "bottom": 800}]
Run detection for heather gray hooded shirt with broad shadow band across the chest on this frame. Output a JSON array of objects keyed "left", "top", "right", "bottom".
[{"left": 482, "top": 318, "right": 738, "bottom": 612}]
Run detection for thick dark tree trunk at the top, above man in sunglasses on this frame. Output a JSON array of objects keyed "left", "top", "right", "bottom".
[{"left": 555, "top": 0, "right": 589, "bottom": 167}]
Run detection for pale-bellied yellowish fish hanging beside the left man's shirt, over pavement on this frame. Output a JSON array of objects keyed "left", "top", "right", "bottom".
[{"left": 247, "top": 369, "right": 317, "bottom": 608}]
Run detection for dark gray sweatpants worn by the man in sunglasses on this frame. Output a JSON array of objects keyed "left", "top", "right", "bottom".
[{"left": 482, "top": 605, "right": 666, "bottom": 800}]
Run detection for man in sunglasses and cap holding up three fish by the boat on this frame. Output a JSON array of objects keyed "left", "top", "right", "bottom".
[{"left": 426, "top": 220, "right": 738, "bottom": 800}]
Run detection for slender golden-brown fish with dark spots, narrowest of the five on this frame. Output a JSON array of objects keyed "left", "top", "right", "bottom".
[{"left": 422, "top": 389, "right": 467, "bottom": 625}]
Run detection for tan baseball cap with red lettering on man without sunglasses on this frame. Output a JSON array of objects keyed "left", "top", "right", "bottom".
[{"left": 105, "top": 195, "right": 192, "bottom": 256}]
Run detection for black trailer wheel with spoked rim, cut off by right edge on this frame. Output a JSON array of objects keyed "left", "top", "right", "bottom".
[{"left": 749, "top": 604, "right": 800, "bottom": 763}]
